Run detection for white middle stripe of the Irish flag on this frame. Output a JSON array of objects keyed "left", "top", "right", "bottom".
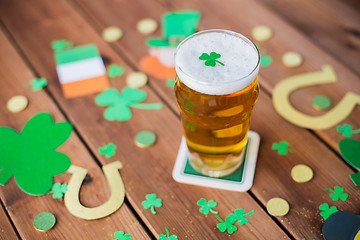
[{"left": 56, "top": 56, "right": 106, "bottom": 84}]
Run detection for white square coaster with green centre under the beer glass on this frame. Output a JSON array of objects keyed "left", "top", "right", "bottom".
[{"left": 172, "top": 131, "right": 260, "bottom": 192}]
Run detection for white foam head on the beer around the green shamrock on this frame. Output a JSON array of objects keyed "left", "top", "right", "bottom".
[{"left": 175, "top": 29, "right": 260, "bottom": 95}]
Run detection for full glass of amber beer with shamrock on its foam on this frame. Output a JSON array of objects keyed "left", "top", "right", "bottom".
[{"left": 174, "top": 29, "right": 260, "bottom": 177}]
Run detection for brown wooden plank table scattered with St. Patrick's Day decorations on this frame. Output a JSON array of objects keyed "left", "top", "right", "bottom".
[{"left": 0, "top": 0, "right": 360, "bottom": 239}]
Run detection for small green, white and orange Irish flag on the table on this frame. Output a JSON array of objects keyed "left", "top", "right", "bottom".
[{"left": 55, "top": 44, "right": 110, "bottom": 98}]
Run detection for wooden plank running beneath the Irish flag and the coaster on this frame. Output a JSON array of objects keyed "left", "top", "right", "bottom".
[{"left": 0, "top": 0, "right": 288, "bottom": 239}]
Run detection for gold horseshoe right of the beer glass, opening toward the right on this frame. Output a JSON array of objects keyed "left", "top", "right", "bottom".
[{"left": 272, "top": 65, "right": 360, "bottom": 129}]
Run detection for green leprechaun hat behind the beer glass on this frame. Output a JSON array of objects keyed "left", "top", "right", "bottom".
[{"left": 146, "top": 10, "right": 201, "bottom": 47}]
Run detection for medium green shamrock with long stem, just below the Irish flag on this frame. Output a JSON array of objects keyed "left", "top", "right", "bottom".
[{"left": 95, "top": 87, "right": 162, "bottom": 121}]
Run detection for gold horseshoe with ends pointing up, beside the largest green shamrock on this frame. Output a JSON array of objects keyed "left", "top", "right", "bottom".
[{"left": 64, "top": 161, "right": 125, "bottom": 220}]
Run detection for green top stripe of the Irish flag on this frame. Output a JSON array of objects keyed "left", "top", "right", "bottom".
[{"left": 55, "top": 44, "right": 100, "bottom": 65}]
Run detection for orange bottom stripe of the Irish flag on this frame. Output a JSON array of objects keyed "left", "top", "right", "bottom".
[{"left": 61, "top": 75, "right": 110, "bottom": 98}]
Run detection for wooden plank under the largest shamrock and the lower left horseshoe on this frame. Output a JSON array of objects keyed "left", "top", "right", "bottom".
[{"left": 0, "top": 29, "right": 150, "bottom": 239}]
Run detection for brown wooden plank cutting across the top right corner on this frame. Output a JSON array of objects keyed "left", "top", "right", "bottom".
[{"left": 260, "top": 0, "right": 360, "bottom": 76}]
